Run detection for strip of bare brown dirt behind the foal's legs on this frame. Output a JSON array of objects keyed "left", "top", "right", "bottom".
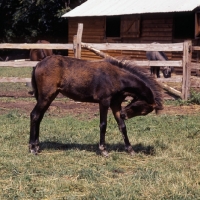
[{"left": 0, "top": 92, "right": 200, "bottom": 116}]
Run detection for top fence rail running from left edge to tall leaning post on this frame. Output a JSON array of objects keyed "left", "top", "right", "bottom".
[{"left": 0, "top": 43, "right": 73, "bottom": 49}]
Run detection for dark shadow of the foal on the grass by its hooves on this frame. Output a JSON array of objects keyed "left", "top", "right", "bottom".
[{"left": 40, "top": 141, "right": 155, "bottom": 155}]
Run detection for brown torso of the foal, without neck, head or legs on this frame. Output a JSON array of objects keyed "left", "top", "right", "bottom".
[{"left": 35, "top": 55, "right": 129, "bottom": 102}]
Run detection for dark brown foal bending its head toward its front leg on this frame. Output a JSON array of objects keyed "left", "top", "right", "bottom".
[{"left": 29, "top": 55, "right": 163, "bottom": 156}]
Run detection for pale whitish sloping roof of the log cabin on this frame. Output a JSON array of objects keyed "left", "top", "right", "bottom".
[{"left": 62, "top": 0, "right": 200, "bottom": 17}]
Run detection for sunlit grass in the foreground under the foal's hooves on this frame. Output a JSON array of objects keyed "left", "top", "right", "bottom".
[{"left": 0, "top": 104, "right": 200, "bottom": 200}]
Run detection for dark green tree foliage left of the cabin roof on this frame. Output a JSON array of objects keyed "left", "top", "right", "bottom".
[{"left": 0, "top": 0, "right": 83, "bottom": 42}]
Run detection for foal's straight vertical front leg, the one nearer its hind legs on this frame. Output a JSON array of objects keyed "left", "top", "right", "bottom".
[{"left": 99, "top": 104, "right": 108, "bottom": 157}]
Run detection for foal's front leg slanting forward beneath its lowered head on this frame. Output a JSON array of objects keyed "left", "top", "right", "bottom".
[{"left": 111, "top": 104, "right": 135, "bottom": 155}]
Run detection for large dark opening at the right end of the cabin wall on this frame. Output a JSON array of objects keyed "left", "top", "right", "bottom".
[{"left": 174, "top": 12, "right": 195, "bottom": 39}]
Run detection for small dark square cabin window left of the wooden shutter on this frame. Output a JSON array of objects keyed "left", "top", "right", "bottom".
[{"left": 106, "top": 16, "right": 121, "bottom": 37}]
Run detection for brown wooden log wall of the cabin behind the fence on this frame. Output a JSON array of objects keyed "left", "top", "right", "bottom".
[{"left": 68, "top": 13, "right": 200, "bottom": 75}]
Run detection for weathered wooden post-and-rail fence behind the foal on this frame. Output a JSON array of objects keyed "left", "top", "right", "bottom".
[{"left": 0, "top": 24, "right": 200, "bottom": 100}]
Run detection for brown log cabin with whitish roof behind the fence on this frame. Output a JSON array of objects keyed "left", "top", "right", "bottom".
[{"left": 63, "top": 0, "right": 200, "bottom": 74}]
